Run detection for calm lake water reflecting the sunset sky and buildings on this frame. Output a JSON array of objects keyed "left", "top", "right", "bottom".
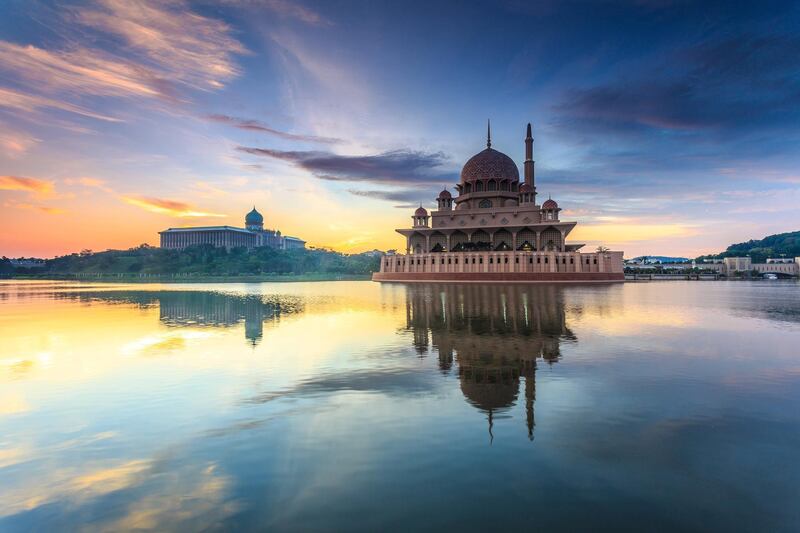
[{"left": 0, "top": 281, "right": 800, "bottom": 532}]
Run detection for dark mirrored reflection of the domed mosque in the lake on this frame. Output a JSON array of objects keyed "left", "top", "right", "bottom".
[{"left": 406, "top": 284, "right": 576, "bottom": 440}]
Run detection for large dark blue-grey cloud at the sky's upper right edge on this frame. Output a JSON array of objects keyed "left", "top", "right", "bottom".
[{"left": 555, "top": 34, "right": 800, "bottom": 136}]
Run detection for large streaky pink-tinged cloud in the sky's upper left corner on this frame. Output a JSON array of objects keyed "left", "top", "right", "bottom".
[{"left": 0, "top": 0, "right": 247, "bottom": 121}]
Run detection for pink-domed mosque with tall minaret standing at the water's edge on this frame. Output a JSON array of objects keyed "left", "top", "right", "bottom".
[{"left": 373, "top": 124, "right": 625, "bottom": 282}]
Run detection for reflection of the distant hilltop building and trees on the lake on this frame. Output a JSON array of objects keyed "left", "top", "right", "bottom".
[{"left": 52, "top": 291, "right": 303, "bottom": 346}]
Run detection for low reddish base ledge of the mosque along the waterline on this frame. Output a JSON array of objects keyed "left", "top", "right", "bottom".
[{"left": 372, "top": 272, "right": 625, "bottom": 283}]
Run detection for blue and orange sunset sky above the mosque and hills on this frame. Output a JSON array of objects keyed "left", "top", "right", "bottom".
[{"left": 0, "top": 0, "right": 800, "bottom": 257}]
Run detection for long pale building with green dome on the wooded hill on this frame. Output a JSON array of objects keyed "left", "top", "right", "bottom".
[{"left": 159, "top": 207, "right": 306, "bottom": 250}]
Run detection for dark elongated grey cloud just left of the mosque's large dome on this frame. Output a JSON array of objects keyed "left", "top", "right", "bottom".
[{"left": 237, "top": 146, "right": 457, "bottom": 185}]
